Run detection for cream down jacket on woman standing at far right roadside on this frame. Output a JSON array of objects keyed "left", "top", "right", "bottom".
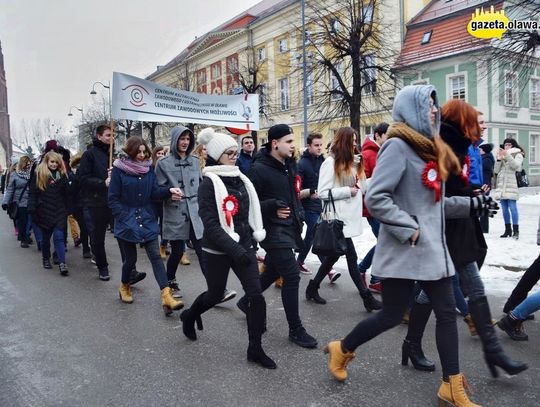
[{"left": 493, "top": 148, "right": 523, "bottom": 201}]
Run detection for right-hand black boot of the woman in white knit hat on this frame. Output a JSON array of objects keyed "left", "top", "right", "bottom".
[{"left": 246, "top": 295, "right": 277, "bottom": 369}]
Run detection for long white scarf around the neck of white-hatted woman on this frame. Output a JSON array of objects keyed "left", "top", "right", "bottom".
[{"left": 203, "top": 165, "right": 266, "bottom": 242}]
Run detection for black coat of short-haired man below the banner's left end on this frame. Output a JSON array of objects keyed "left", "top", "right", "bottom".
[{"left": 77, "top": 138, "right": 110, "bottom": 207}]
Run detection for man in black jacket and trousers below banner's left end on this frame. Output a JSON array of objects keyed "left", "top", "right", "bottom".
[{"left": 77, "top": 125, "right": 113, "bottom": 281}]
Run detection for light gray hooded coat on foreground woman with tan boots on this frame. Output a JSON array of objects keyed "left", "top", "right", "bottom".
[{"left": 366, "top": 85, "right": 470, "bottom": 281}]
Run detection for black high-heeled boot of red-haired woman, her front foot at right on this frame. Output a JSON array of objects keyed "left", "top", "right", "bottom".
[{"left": 469, "top": 296, "right": 528, "bottom": 377}]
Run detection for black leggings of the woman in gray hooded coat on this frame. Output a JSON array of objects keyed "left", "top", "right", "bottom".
[{"left": 343, "top": 277, "right": 459, "bottom": 377}]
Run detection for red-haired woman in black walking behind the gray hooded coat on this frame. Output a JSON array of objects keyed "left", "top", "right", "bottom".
[{"left": 403, "top": 99, "right": 527, "bottom": 377}]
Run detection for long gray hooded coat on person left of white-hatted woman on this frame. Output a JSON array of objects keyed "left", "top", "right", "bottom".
[{"left": 156, "top": 126, "right": 203, "bottom": 240}]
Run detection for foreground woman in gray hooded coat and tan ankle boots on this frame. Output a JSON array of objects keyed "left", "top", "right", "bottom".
[{"left": 325, "top": 85, "right": 487, "bottom": 406}]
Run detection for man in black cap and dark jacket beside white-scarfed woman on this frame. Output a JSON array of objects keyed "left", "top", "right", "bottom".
[{"left": 241, "top": 124, "right": 317, "bottom": 348}]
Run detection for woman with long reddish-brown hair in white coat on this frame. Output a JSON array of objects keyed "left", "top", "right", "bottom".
[{"left": 306, "top": 127, "right": 382, "bottom": 312}]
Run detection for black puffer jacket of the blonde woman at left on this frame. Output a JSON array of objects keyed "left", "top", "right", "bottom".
[{"left": 28, "top": 171, "right": 69, "bottom": 229}]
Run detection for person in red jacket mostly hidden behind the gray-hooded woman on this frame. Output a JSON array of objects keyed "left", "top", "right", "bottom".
[{"left": 358, "top": 122, "right": 388, "bottom": 294}]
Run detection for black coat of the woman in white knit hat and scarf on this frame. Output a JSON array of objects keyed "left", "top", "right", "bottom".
[{"left": 197, "top": 173, "right": 255, "bottom": 259}]
